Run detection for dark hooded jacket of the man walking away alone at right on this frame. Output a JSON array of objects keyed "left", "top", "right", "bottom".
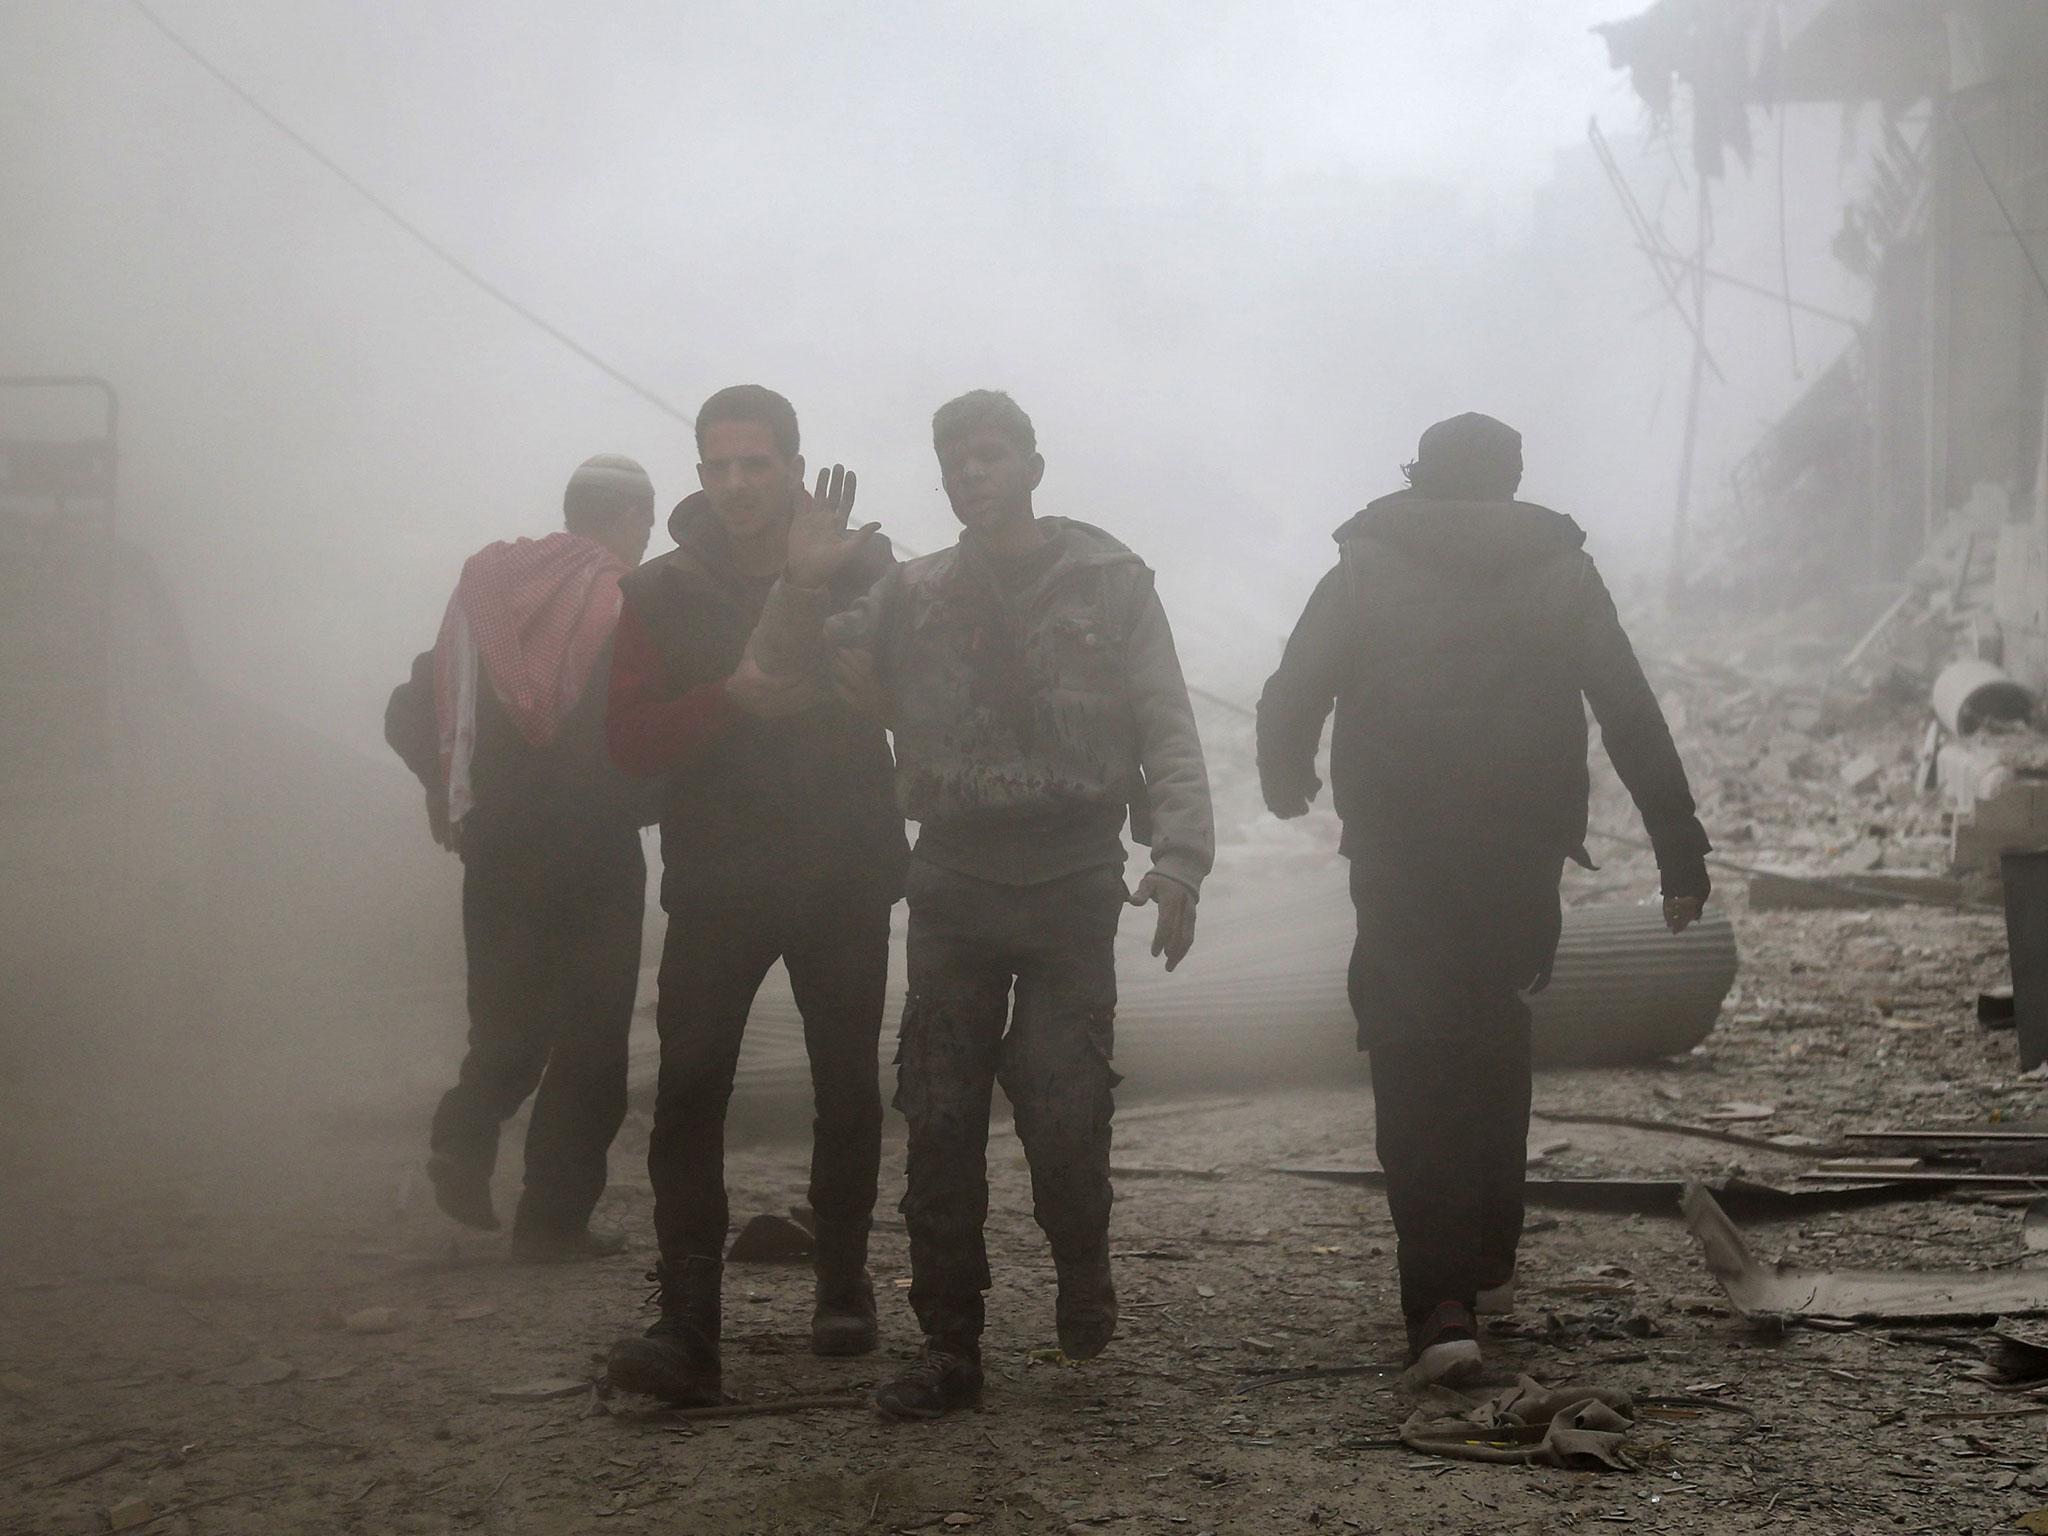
[{"left": 1260, "top": 492, "right": 1708, "bottom": 895}]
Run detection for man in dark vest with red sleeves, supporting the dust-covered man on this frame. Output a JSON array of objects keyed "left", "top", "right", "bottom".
[{"left": 608, "top": 385, "right": 907, "bottom": 1403}]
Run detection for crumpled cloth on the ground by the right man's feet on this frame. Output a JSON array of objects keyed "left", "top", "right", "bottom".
[{"left": 1401, "top": 1376, "right": 1636, "bottom": 1473}]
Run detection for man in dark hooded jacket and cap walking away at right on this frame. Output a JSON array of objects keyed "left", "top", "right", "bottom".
[{"left": 1257, "top": 416, "right": 1710, "bottom": 1380}]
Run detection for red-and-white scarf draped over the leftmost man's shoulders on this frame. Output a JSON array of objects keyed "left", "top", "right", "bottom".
[{"left": 434, "top": 532, "right": 627, "bottom": 821}]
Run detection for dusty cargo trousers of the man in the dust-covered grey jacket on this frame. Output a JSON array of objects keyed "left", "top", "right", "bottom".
[{"left": 895, "top": 860, "right": 1124, "bottom": 1341}]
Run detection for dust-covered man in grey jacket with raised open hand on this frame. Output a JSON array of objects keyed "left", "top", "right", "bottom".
[{"left": 756, "top": 389, "right": 1214, "bottom": 1419}]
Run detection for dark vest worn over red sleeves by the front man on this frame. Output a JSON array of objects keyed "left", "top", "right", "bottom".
[{"left": 621, "top": 496, "right": 909, "bottom": 909}]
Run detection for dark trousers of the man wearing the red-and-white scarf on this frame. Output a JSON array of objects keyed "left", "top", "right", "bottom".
[{"left": 432, "top": 807, "right": 647, "bottom": 1231}]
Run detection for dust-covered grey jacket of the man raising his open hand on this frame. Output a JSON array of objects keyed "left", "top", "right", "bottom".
[{"left": 754, "top": 518, "right": 1217, "bottom": 891}]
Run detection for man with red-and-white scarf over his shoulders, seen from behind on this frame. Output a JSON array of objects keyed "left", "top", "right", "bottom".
[{"left": 385, "top": 455, "right": 653, "bottom": 1262}]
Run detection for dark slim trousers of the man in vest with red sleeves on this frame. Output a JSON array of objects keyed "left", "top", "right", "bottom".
[{"left": 647, "top": 879, "right": 895, "bottom": 1264}]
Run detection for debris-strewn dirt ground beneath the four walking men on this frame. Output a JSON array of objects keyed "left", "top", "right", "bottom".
[{"left": 0, "top": 876, "right": 2048, "bottom": 1536}]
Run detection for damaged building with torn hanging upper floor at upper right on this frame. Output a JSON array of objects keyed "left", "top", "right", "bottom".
[{"left": 1599, "top": 0, "right": 2048, "bottom": 874}]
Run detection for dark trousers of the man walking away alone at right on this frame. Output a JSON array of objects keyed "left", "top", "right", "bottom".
[{"left": 1350, "top": 850, "right": 1561, "bottom": 1325}]
